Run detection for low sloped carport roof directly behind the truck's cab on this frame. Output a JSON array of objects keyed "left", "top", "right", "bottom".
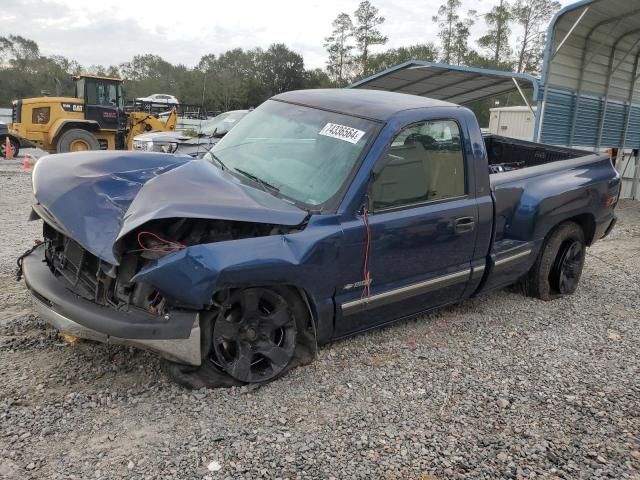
[{"left": 349, "top": 60, "right": 538, "bottom": 105}]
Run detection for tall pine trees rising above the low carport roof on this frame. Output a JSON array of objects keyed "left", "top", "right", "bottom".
[{"left": 324, "top": 0, "right": 561, "bottom": 86}]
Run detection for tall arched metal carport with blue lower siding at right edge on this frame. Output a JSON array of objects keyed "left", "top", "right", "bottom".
[{"left": 536, "top": 0, "right": 640, "bottom": 198}]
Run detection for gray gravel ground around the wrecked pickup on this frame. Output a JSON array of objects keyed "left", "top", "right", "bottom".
[{"left": 0, "top": 162, "right": 640, "bottom": 480}]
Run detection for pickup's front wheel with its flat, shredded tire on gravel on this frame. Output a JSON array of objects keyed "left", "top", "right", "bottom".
[{"left": 162, "top": 286, "right": 317, "bottom": 389}]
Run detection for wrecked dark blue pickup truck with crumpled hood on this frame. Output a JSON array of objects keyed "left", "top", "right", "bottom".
[{"left": 19, "top": 89, "right": 620, "bottom": 388}]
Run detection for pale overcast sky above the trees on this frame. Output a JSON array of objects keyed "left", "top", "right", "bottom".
[{"left": 0, "top": 0, "right": 572, "bottom": 67}]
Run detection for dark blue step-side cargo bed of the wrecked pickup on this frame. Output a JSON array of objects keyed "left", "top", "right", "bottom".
[{"left": 485, "top": 136, "right": 619, "bottom": 289}]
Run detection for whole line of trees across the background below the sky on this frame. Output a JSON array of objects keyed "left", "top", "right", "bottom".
[{"left": 0, "top": 0, "right": 560, "bottom": 111}]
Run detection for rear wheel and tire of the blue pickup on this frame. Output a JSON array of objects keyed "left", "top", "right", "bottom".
[{"left": 523, "top": 222, "right": 587, "bottom": 301}]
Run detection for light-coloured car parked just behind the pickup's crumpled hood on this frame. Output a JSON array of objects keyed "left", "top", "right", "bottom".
[{"left": 133, "top": 110, "right": 249, "bottom": 158}]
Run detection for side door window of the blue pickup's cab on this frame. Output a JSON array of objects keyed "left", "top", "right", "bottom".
[{"left": 371, "top": 120, "right": 466, "bottom": 211}]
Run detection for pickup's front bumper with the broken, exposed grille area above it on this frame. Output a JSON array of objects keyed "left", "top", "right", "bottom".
[{"left": 22, "top": 223, "right": 201, "bottom": 365}]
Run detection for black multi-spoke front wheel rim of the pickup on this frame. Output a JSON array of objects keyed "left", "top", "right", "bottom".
[{"left": 213, "top": 288, "right": 297, "bottom": 383}]
